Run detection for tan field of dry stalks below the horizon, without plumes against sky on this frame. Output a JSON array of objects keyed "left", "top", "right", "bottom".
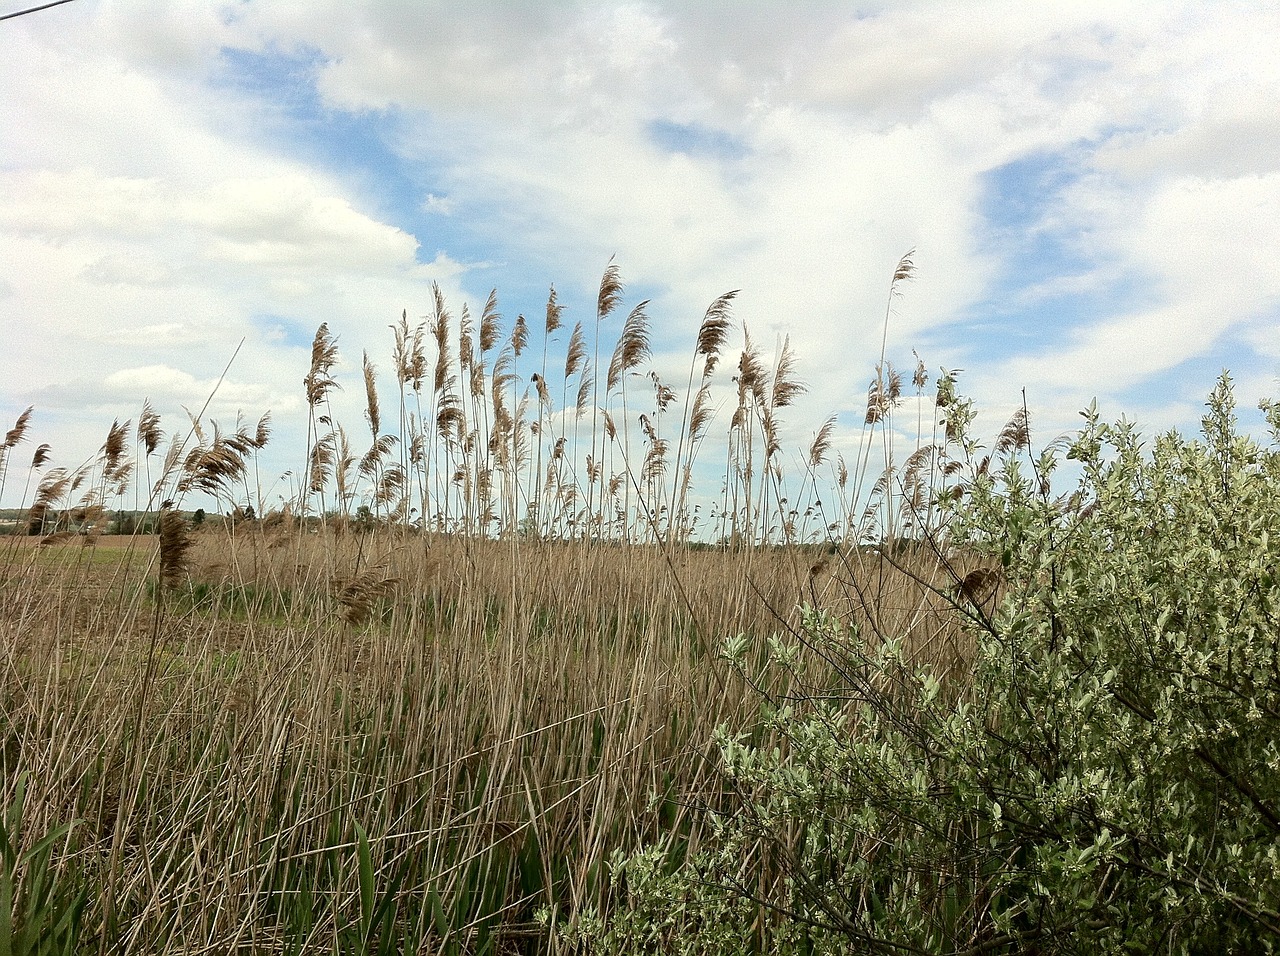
[{"left": 0, "top": 526, "right": 964, "bottom": 952}]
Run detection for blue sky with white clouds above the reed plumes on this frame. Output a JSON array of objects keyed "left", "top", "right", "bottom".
[{"left": 0, "top": 0, "right": 1280, "bottom": 519}]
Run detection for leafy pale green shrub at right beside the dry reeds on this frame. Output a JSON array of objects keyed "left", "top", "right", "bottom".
[{"left": 581, "top": 375, "right": 1280, "bottom": 953}]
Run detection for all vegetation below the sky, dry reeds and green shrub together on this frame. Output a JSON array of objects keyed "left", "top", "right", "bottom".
[{"left": 0, "top": 257, "right": 1280, "bottom": 953}]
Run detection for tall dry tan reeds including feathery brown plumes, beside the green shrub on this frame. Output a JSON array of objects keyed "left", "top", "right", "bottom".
[{"left": 0, "top": 260, "right": 1003, "bottom": 953}]
